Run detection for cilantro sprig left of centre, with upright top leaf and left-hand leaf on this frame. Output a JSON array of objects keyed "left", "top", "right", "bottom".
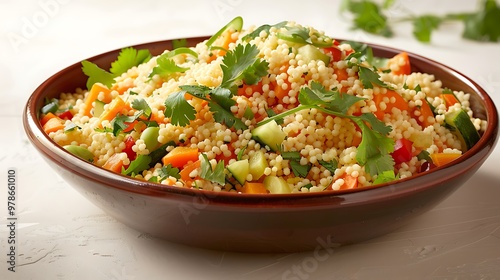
[{"left": 165, "top": 44, "right": 269, "bottom": 130}]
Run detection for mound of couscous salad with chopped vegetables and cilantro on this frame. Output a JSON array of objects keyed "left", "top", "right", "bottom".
[{"left": 40, "top": 17, "right": 486, "bottom": 194}]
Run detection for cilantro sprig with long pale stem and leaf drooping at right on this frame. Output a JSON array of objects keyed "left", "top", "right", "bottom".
[{"left": 257, "top": 82, "right": 394, "bottom": 176}]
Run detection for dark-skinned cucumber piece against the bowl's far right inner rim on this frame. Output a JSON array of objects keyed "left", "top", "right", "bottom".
[{"left": 444, "top": 109, "right": 481, "bottom": 150}]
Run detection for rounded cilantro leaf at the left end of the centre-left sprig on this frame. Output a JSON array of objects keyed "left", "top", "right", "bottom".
[{"left": 165, "top": 90, "right": 196, "bottom": 126}]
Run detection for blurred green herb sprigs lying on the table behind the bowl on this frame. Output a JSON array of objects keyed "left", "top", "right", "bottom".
[{"left": 341, "top": 0, "right": 500, "bottom": 43}]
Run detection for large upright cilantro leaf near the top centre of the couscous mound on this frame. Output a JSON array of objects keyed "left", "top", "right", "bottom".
[{"left": 220, "top": 44, "right": 269, "bottom": 93}]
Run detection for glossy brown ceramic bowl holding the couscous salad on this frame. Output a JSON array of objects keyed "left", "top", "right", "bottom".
[{"left": 23, "top": 38, "right": 498, "bottom": 252}]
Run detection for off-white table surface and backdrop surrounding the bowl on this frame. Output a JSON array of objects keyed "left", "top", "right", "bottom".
[{"left": 0, "top": 0, "right": 500, "bottom": 280}]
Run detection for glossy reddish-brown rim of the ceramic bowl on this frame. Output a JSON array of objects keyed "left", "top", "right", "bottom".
[{"left": 22, "top": 36, "right": 498, "bottom": 208}]
